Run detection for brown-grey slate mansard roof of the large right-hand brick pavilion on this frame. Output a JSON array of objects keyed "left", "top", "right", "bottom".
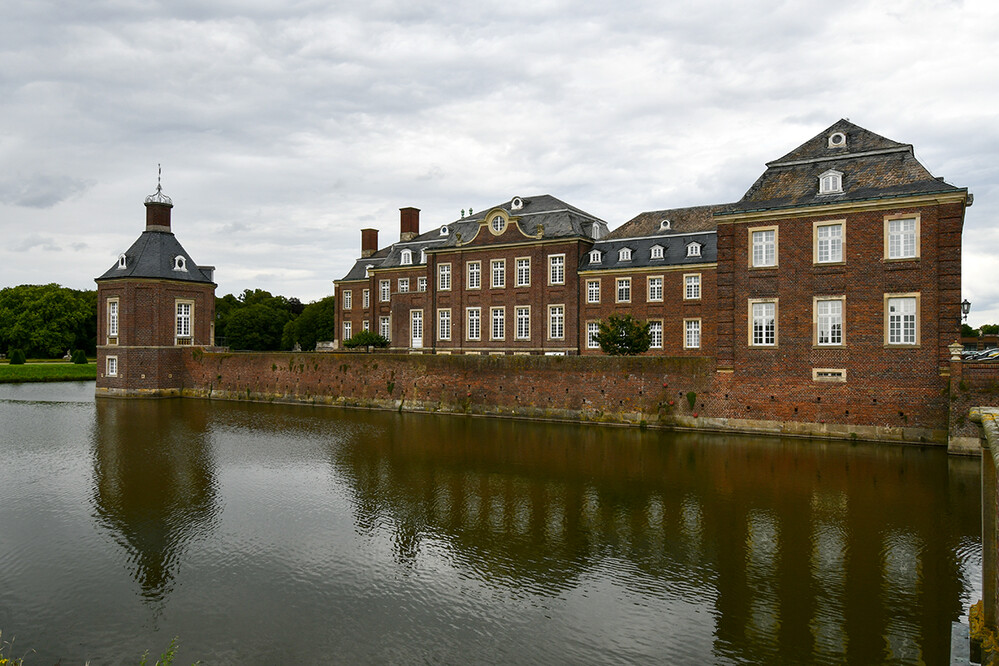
[{"left": 719, "top": 120, "right": 962, "bottom": 215}]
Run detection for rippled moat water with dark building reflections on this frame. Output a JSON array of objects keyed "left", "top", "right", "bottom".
[{"left": 0, "top": 383, "right": 981, "bottom": 666}]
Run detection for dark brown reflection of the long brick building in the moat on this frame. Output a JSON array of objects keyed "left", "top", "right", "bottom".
[{"left": 333, "top": 417, "right": 977, "bottom": 663}]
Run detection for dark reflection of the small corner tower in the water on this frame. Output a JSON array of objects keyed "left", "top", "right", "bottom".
[{"left": 93, "top": 400, "right": 218, "bottom": 600}]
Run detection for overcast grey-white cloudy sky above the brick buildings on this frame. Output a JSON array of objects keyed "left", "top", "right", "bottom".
[{"left": 0, "top": 0, "right": 999, "bottom": 325}]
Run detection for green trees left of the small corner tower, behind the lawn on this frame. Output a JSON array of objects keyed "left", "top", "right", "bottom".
[{"left": 0, "top": 284, "right": 97, "bottom": 358}]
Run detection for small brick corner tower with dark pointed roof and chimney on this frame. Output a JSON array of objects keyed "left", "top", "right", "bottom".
[{"left": 95, "top": 176, "right": 216, "bottom": 397}]
